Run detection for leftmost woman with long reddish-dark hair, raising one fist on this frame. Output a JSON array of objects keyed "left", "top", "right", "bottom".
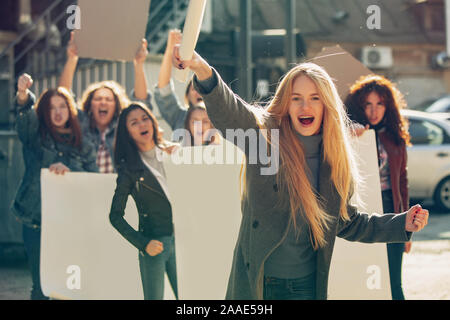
[{"left": 12, "top": 74, "right": 98, "bottom": 299}]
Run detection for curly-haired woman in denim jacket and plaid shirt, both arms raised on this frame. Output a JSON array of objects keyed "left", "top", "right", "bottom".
[{"left": 59, "top": 32, "right": 152, "bottom": 173}]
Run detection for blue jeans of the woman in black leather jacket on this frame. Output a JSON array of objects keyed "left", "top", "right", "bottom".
[{"left": 139, "top": 236, "right": 178, "bottom": 300}]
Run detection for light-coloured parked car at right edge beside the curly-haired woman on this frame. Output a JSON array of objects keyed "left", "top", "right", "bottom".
[{"left": 401, "top": 110, "right": 450, "bottom": 213}]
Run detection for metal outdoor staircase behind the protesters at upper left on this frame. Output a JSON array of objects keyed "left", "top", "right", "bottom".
[{"left": 0, "top": 0, "right": 189, "bottom": 129}]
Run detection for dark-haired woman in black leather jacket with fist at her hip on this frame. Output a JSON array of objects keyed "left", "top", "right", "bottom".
[{"left": 109, "top": 102, "right": 178, "bottom": 300}]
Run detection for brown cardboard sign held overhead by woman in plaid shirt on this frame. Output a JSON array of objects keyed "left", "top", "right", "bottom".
[{"left": 75, "top": 0, "right": 150, "bottom": 61}]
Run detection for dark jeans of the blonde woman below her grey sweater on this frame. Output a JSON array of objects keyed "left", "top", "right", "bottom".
[{"left": 264, "top": 272, "right": 316, "bottom": 300}]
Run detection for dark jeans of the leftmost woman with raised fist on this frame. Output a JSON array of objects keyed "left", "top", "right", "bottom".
[{"left": 23, "top": 225, "right": 48, "bottom": 300}]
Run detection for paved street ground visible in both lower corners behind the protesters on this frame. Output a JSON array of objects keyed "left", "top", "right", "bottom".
[{"left": 0, "top": 205, "right": 450, "bottom": 300}]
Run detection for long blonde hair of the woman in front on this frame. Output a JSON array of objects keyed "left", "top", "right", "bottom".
[{"left": 256, "top": 63, "right": 359, "bottom": 249}]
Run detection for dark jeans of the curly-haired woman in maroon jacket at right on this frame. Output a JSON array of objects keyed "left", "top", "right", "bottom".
[{"left": 382, "top": 190, "right": 405, "bottom": 300}]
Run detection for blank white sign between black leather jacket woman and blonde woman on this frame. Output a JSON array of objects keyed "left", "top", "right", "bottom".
[{"left": 164, "top": 140, "right": 244, "bottom": 300}]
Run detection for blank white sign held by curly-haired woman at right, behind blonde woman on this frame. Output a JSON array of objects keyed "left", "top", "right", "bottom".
[{"left": 328, "top": 130, "right": 391, "bottom": 300}]
